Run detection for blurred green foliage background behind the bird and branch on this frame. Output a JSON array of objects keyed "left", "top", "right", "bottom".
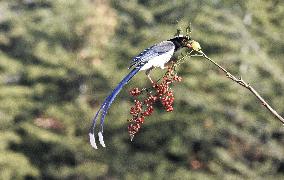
[{"left": 0, "top": 0, "right": 284, "bottom": 179}]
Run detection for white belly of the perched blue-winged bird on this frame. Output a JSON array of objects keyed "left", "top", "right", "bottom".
[{"left": 140, "top": 49, "right": 174, "bottom": 71}]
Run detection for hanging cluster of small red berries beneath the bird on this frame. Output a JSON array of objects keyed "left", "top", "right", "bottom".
[{"left": 128, "top": 66, "right": 181, "bottom": 140}]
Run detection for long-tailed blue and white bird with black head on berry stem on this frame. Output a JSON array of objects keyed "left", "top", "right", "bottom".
[{"left": 89, "top": 34, "right": 201, "bottom": 149}]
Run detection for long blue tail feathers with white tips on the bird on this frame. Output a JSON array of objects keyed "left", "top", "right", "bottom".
[{"left": 89, "top": 68, "right": 141, "bottom": 149}]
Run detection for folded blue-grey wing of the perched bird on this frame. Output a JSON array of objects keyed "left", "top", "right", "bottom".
[{"left": 129, "top": 41, "right": 175, "bottom": 69}]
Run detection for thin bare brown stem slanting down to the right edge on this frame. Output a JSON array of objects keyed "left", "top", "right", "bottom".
[{"left": 199, "top": 50, "right": 284, "bottom": 125}]
